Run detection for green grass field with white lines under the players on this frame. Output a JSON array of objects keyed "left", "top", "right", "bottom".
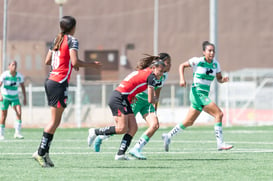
[{"left": 0, "top": 126, "right": 273, "bottom": 181}]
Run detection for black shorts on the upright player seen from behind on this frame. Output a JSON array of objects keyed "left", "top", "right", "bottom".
[{"left": 45, "top": 79, "right": 68, "bottom": 108}]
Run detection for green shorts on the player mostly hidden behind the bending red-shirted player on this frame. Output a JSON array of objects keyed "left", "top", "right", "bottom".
[{"left": 131, "top": 99, "right": 155, "bottom": 116}]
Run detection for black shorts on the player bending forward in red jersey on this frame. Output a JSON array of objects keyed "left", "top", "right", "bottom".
[{"left": 108, "top": 90, "right": 133, "bottom": 116}]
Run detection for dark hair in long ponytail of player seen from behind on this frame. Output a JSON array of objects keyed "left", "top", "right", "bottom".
[{"left": 53, "top": 16, "right": 76, "bottom": 51}]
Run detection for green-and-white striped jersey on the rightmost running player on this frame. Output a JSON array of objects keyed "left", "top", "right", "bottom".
[{"left": 189, "top": 57, "right": 221, "bottom": 92}]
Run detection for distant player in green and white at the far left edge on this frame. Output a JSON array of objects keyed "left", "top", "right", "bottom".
[{"left": 0, "top": 61, "right": 26, "bottom": 141}]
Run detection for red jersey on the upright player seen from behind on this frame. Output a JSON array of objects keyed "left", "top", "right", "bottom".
[{"left": 48, "top": 35, "right": 79, "bottom": 83}]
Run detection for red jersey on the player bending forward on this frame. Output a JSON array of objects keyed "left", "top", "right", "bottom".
[{"left": 116, "top": 68, "right": 161, "bottom": 103}]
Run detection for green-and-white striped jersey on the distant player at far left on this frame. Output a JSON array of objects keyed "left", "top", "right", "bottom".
[{"left": 0, "top": 70, "right": 24, "bottom": 100}]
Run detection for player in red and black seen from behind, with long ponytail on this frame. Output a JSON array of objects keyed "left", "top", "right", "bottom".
[{"left": 32, "top": 16, "right": 101, "bottom": 167}]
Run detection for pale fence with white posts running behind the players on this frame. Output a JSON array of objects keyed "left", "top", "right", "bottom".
[{"left": 5, "top": 75, "right": 273, "bottom": 127}]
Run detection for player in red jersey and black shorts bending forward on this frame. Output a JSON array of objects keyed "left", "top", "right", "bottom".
[{"left": 87, "top": 56, "right": 165, "bottom": 160}]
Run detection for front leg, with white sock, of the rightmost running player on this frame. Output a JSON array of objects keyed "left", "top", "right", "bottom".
[{"left": 203, "top": 102, "right": 233, "bottom": 151}]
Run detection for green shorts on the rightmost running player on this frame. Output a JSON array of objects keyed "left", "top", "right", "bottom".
[{"left": 190, "top": 87, "right": 212, "bottom": 112}]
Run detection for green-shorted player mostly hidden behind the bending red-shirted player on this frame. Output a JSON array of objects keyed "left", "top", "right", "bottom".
[{"left": 91, "top": 53, "right": 171, "bottom": 160}]
